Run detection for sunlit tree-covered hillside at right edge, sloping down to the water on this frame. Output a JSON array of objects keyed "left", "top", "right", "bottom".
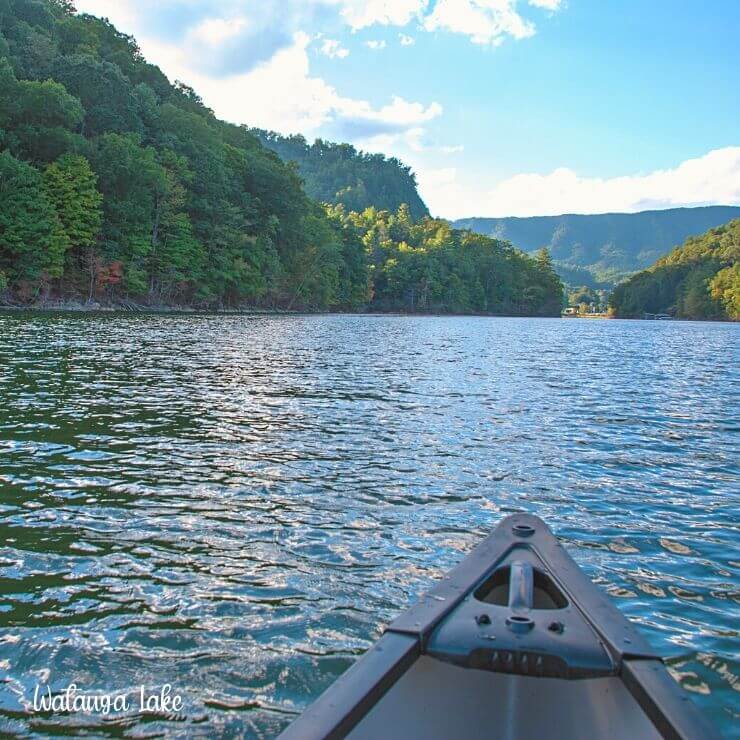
[{"left": 609, "top": 219, "right": 740, "bottom": 320}]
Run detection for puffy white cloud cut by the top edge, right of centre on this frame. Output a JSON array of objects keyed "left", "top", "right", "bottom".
[{"left": 424, "top": 0, "right": 536, "bottom": 45}]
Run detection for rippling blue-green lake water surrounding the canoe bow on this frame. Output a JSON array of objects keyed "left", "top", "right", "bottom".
[{"left": 0, "top": 314, "right": 740, "bottom": 737}]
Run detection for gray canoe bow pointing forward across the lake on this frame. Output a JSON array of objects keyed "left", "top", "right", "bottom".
[{"left": 281, "top": 514, "right": 719, "bottom": 740}]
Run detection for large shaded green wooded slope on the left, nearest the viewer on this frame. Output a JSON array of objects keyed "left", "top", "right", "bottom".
[{"left": 0, "top": 0, "right": 346, "bottom": 306}]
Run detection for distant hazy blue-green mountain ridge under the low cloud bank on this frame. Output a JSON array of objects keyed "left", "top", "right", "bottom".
[{"left": 453, "top": 206, "right": 740, "bottom": 287}]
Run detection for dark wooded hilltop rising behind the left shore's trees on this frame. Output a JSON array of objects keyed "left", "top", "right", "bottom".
[{"left": 250, "top": 129, "right": 429, "bottom": 219}]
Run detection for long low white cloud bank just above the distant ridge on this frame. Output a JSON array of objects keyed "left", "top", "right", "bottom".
[{"left": 418, "top": 147, "right": 740, "bottom": 218}]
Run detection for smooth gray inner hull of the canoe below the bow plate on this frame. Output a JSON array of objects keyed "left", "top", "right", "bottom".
[{"left": 348, "top": 656, "right": 660, "bottom": 740}]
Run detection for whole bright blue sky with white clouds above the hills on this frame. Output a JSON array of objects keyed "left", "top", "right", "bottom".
[{"left": 76, "top": 0, "right": 740, "bottom": 218}]
